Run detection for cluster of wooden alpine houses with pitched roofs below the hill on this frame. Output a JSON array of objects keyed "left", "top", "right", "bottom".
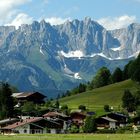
[{"left": 0, "top": 92, "right": 140, "bottom": 134}]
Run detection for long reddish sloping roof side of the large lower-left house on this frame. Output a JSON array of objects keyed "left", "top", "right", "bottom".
[{"left": 2, "top": 117, "right": 43, "bottom": 129}]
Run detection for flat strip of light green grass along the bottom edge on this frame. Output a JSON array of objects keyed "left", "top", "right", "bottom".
[{"left": 0, "top": 134, "right": 140, "bottom": 140}]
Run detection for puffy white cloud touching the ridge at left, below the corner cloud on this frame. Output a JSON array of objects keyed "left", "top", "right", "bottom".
[{"left": 7, "top": 13, "right": 33, "bottom": 29}]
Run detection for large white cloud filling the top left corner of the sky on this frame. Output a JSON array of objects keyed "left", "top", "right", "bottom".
[{"left": 0, "top": 0, "right": 31, "bottom": 24}]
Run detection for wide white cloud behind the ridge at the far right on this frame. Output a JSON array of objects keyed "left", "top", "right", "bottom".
[{"left": 97, "top": 15, "right": 136, "bottom": 30}]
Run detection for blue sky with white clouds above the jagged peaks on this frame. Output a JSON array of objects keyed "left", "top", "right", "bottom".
[{"left": 0, "top": 0, "right": 140, "bottom": 29}]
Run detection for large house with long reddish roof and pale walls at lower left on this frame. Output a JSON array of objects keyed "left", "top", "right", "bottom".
[{"left": 1, "top": 117, "right": 60, "bottom": 134}]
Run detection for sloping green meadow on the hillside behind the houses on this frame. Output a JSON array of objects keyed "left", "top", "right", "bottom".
[{"left": 60, "top": 80, "right": 138, "bottom": 112}]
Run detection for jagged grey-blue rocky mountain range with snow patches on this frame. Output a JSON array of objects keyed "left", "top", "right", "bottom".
[{"left": 0, "top": 17, "right": 140, "bottom": 97}]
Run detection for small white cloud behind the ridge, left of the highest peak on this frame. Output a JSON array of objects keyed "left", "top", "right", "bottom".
[{"left": 45, "top": 17, "right": 71, "bottom": 25}]
